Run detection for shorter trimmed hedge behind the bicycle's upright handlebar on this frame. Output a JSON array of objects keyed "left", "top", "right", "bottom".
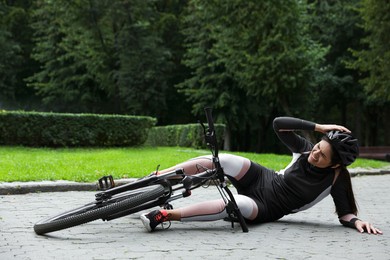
[{"left": 146, "top": 124, "right": 225, "bottom": 149}]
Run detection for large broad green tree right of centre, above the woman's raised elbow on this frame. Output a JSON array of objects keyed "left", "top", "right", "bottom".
[{"left": 179, "top": 0, "right": 325, "bottom": 151}]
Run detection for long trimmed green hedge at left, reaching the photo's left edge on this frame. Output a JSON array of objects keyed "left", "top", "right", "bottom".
[{"left": 0, "top": 111, "right": 156, "bottom": 147}]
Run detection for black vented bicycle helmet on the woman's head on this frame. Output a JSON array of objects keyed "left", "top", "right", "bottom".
[{"left": 326, "top": 131, "right": 359, "bottom": 166}]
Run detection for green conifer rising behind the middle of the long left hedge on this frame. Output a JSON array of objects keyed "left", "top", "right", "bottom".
[{"left": 28, "top": 1, "right": 102, "bottom": 112}]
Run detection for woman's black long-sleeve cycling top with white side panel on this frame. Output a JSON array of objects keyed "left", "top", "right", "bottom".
[{"left": 264, "top": 117, "right": 353, "bottom": 220}]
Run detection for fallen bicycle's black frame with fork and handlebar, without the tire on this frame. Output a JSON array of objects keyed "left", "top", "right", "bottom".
[{"left": 95, "top": 108, "right": 248, "bottom": 232}]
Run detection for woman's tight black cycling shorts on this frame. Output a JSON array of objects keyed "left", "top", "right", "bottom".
[{"left": 227, "top": 162, "right": 285, "bottom": 223}]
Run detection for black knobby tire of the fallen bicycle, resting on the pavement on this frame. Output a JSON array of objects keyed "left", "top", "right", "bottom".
[{"left": 34, "top": 185, "right": 165, "bottom": 235}]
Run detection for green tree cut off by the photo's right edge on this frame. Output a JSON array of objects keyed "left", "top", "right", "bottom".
[{"left": 349, "top": 0, "right": 390, "bottom": 145}]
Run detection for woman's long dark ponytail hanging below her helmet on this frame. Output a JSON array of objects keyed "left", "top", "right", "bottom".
[{"left": 322, "top": 135, "right": 358, "bottom": 215}]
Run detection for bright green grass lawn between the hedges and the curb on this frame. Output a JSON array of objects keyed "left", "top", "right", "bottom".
[{"left": 0, "top": 146, "right": 390, "bottom": 182}]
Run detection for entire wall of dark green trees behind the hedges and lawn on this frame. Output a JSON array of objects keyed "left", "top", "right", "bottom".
[{"left": 0, "top": 0, "right": 390, "bottom": 149}]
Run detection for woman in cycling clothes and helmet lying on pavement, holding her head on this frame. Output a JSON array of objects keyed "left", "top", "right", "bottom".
[{"left": 141, "top": 117, "right": 382, "bottom": 234}]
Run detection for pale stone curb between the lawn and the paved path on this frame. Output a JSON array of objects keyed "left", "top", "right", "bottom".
[{"left": 0, "top": 167, "right": 390, "bottom": 195}]
